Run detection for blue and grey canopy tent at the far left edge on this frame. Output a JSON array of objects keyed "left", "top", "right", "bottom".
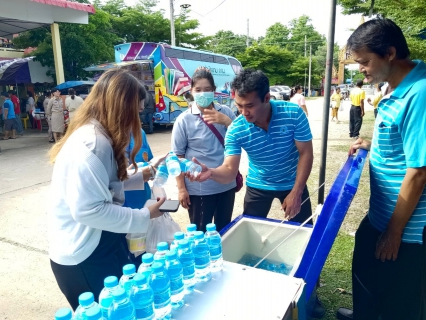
[{"left": 0, "top": 57, "right": 54, "bottom": 85}]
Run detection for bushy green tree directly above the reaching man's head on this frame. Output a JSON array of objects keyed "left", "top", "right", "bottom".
[{"left": 237, "top": 43, "right": 294, "bottom": 85}]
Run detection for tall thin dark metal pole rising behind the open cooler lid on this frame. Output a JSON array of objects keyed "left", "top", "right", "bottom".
[{"left": 318, "top": 0, "right": 337, "bottom": 203}]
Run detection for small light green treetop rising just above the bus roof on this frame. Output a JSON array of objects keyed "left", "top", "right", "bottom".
[{"left": 207, "top": 30, "right": 251, "bottom": 57}]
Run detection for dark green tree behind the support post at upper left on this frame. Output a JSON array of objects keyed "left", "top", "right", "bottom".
[{"left": 14, "top": 10, "right": 119, "bottom": 80}]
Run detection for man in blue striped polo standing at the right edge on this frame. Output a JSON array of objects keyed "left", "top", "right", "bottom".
[{"left": 337, "top": 19, "right": 426, "bottom": 320}]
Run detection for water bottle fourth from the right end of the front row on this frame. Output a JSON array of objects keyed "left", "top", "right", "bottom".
[{"left": 166, "top": 250, "right": 185, "bottom": 310}]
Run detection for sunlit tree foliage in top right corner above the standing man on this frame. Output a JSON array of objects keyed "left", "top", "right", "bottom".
[{"left": 339, "top": 0, "right": 426, "bottom": 60}]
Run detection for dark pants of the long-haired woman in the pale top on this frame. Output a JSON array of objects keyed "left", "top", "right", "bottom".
[{"left": 50, "top": 231, "right": 131, "bottom": 310}]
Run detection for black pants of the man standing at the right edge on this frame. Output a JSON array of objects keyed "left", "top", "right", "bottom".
[{"left": 352, "top": 216, "right": 426, "bottom": 320}]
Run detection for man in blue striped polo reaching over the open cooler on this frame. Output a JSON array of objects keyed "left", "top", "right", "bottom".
[{"left": 200, "top": 69, "right": 313, "bottom": 222}]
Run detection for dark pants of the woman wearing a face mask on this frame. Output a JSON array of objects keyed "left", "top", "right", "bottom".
[{"left": 188, "top": 188, "right": 235, "bottom": 232}]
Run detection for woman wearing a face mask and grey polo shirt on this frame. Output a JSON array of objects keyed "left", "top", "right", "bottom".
[{"left": 172, "top": 68, "right": 236, "bottom": 231}]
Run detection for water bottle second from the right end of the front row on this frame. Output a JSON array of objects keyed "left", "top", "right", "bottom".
[{"left": 193, "top": 231, "right": 212, "bottom": 282}]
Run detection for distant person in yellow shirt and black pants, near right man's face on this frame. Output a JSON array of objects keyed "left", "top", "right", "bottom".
[{"left": 349, "top": 80, "right": 365, "bottom": 139}]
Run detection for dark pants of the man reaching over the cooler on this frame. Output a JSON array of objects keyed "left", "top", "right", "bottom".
[{"left": 244, "top": 186, "right": 312, "bottom": 224}]
